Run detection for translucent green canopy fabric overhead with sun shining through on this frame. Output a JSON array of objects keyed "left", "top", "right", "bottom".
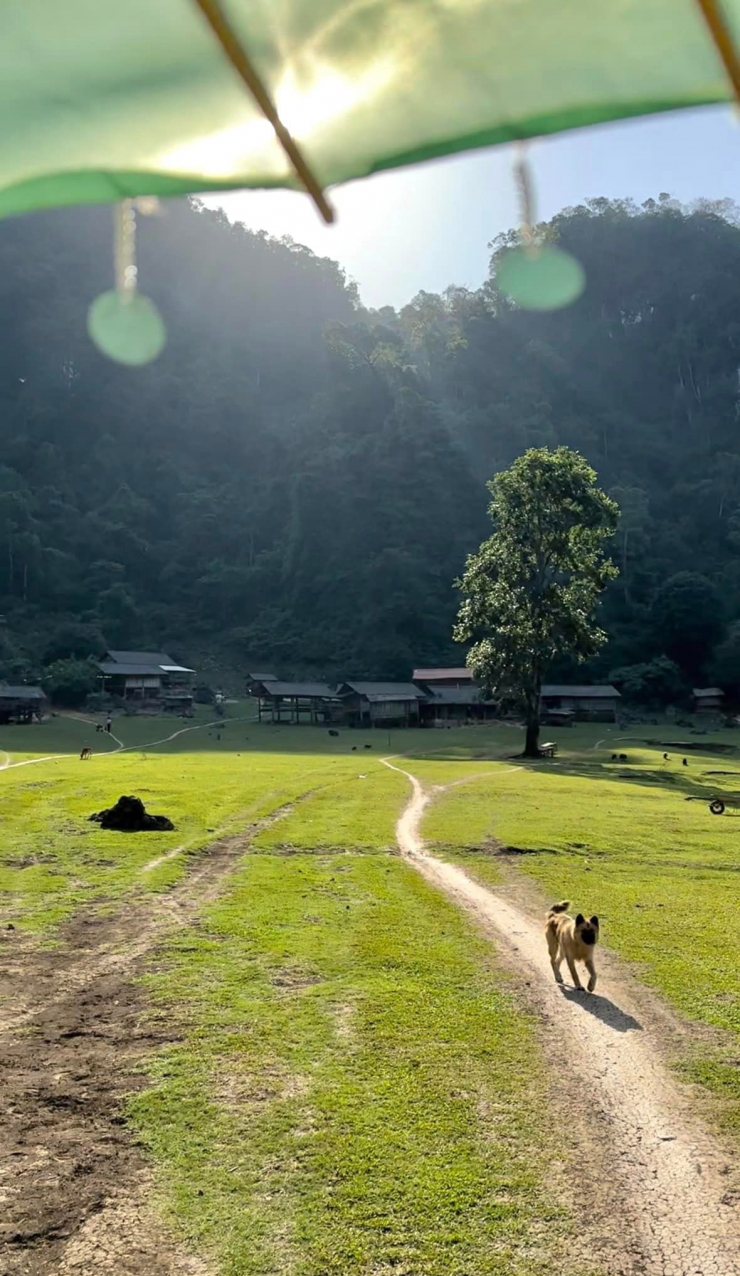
[{"left": 0, "top": 0, "right": 740, "bottom": 222}]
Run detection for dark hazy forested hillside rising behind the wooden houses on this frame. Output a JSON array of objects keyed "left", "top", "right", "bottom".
[{"left": 0, "top": 197, "right": 740, "bottom": 695}]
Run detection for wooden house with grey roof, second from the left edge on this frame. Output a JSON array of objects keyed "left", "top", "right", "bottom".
[{"left": 98, "top": 651, "right": 195, "bottom": 713}]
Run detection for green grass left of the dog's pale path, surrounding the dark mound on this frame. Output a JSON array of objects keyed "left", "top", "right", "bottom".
[{"left": 0, "top": 709, "right": 591, "bottom": 1276}]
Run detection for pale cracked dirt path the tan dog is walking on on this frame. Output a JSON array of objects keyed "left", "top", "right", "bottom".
[{"left": 384, "top": 759, "right": 740, "bottom": 1276}]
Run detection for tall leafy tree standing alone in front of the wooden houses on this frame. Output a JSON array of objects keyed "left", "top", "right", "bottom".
[{"left": 454, "top": 448, "right": 619, "bottom": 758}]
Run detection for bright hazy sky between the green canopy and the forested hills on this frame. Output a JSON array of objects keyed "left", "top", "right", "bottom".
[{"left": 207, "top": 107, "right": 740, "bottom": 306}]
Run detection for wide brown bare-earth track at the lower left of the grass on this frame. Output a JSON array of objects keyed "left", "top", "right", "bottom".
[{"left": 0, "top": 805, "right": 292, "bottom": 1276}]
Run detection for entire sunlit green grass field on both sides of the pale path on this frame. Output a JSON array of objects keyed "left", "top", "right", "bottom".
[{"left": 11, "top": 707, "right": 740, "bottom": 1276}]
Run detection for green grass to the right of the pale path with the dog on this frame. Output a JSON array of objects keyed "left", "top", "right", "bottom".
[{"left": 415, "top": 726, "right": 740, "bottom": 1132}]
